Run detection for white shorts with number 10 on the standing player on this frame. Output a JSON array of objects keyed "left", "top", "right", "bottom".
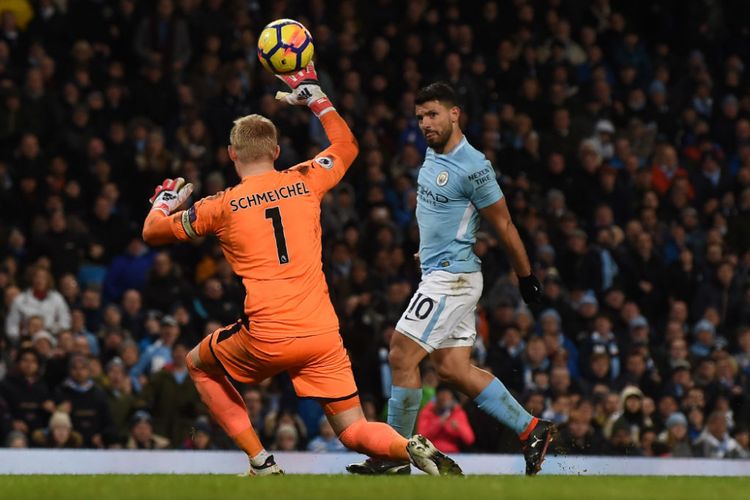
[{"left": 396, "top": 271, "right": 483, "bottom": 352}]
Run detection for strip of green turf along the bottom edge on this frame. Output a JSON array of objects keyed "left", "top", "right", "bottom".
[{"left": 0, "top": 475, "right": 750, "bottom": 500}]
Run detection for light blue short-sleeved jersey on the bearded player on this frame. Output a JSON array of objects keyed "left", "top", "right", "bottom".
[{"left": 417, "top": 137, "right": 503, "bottom": 275}]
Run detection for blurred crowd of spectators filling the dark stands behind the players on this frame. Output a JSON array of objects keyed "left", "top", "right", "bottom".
[{"left": 0, "top": 0, "right": 750, "bottom": 458}]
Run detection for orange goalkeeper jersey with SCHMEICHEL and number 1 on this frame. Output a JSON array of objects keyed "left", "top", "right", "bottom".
[{"left": 171, "top": 110, "right": 358, "bottom": 337}]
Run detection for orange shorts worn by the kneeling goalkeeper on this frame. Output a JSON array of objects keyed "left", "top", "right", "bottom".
[{"left": 199, "top": 321, "right": 357, "bottom": 400}]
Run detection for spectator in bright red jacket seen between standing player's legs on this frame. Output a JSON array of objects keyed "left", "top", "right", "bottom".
[{"left": 417, "top": 386, "right": 474, "bottom": 453}]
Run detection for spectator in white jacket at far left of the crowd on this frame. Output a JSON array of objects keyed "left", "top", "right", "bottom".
[{"left": 5, "top": 268, "right": 70, "bottom": 343}]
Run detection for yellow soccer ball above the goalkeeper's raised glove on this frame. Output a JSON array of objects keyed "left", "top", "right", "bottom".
[{"left": 258, "top": 19, "right": 314, "bottom": 73}]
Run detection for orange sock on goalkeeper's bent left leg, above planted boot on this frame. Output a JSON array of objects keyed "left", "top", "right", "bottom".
[{"left": 188, "top": 356, "right": 263, "bottom": 458}]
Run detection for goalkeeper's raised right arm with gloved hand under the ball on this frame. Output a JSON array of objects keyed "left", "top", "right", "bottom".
[{"left": 276, "top": 63, "right": 359, "bottom": 195}]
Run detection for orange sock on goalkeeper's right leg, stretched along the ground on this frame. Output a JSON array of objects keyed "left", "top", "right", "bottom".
[{"left": 339, "top": 418, "right": 409, "bottom": 462}]
